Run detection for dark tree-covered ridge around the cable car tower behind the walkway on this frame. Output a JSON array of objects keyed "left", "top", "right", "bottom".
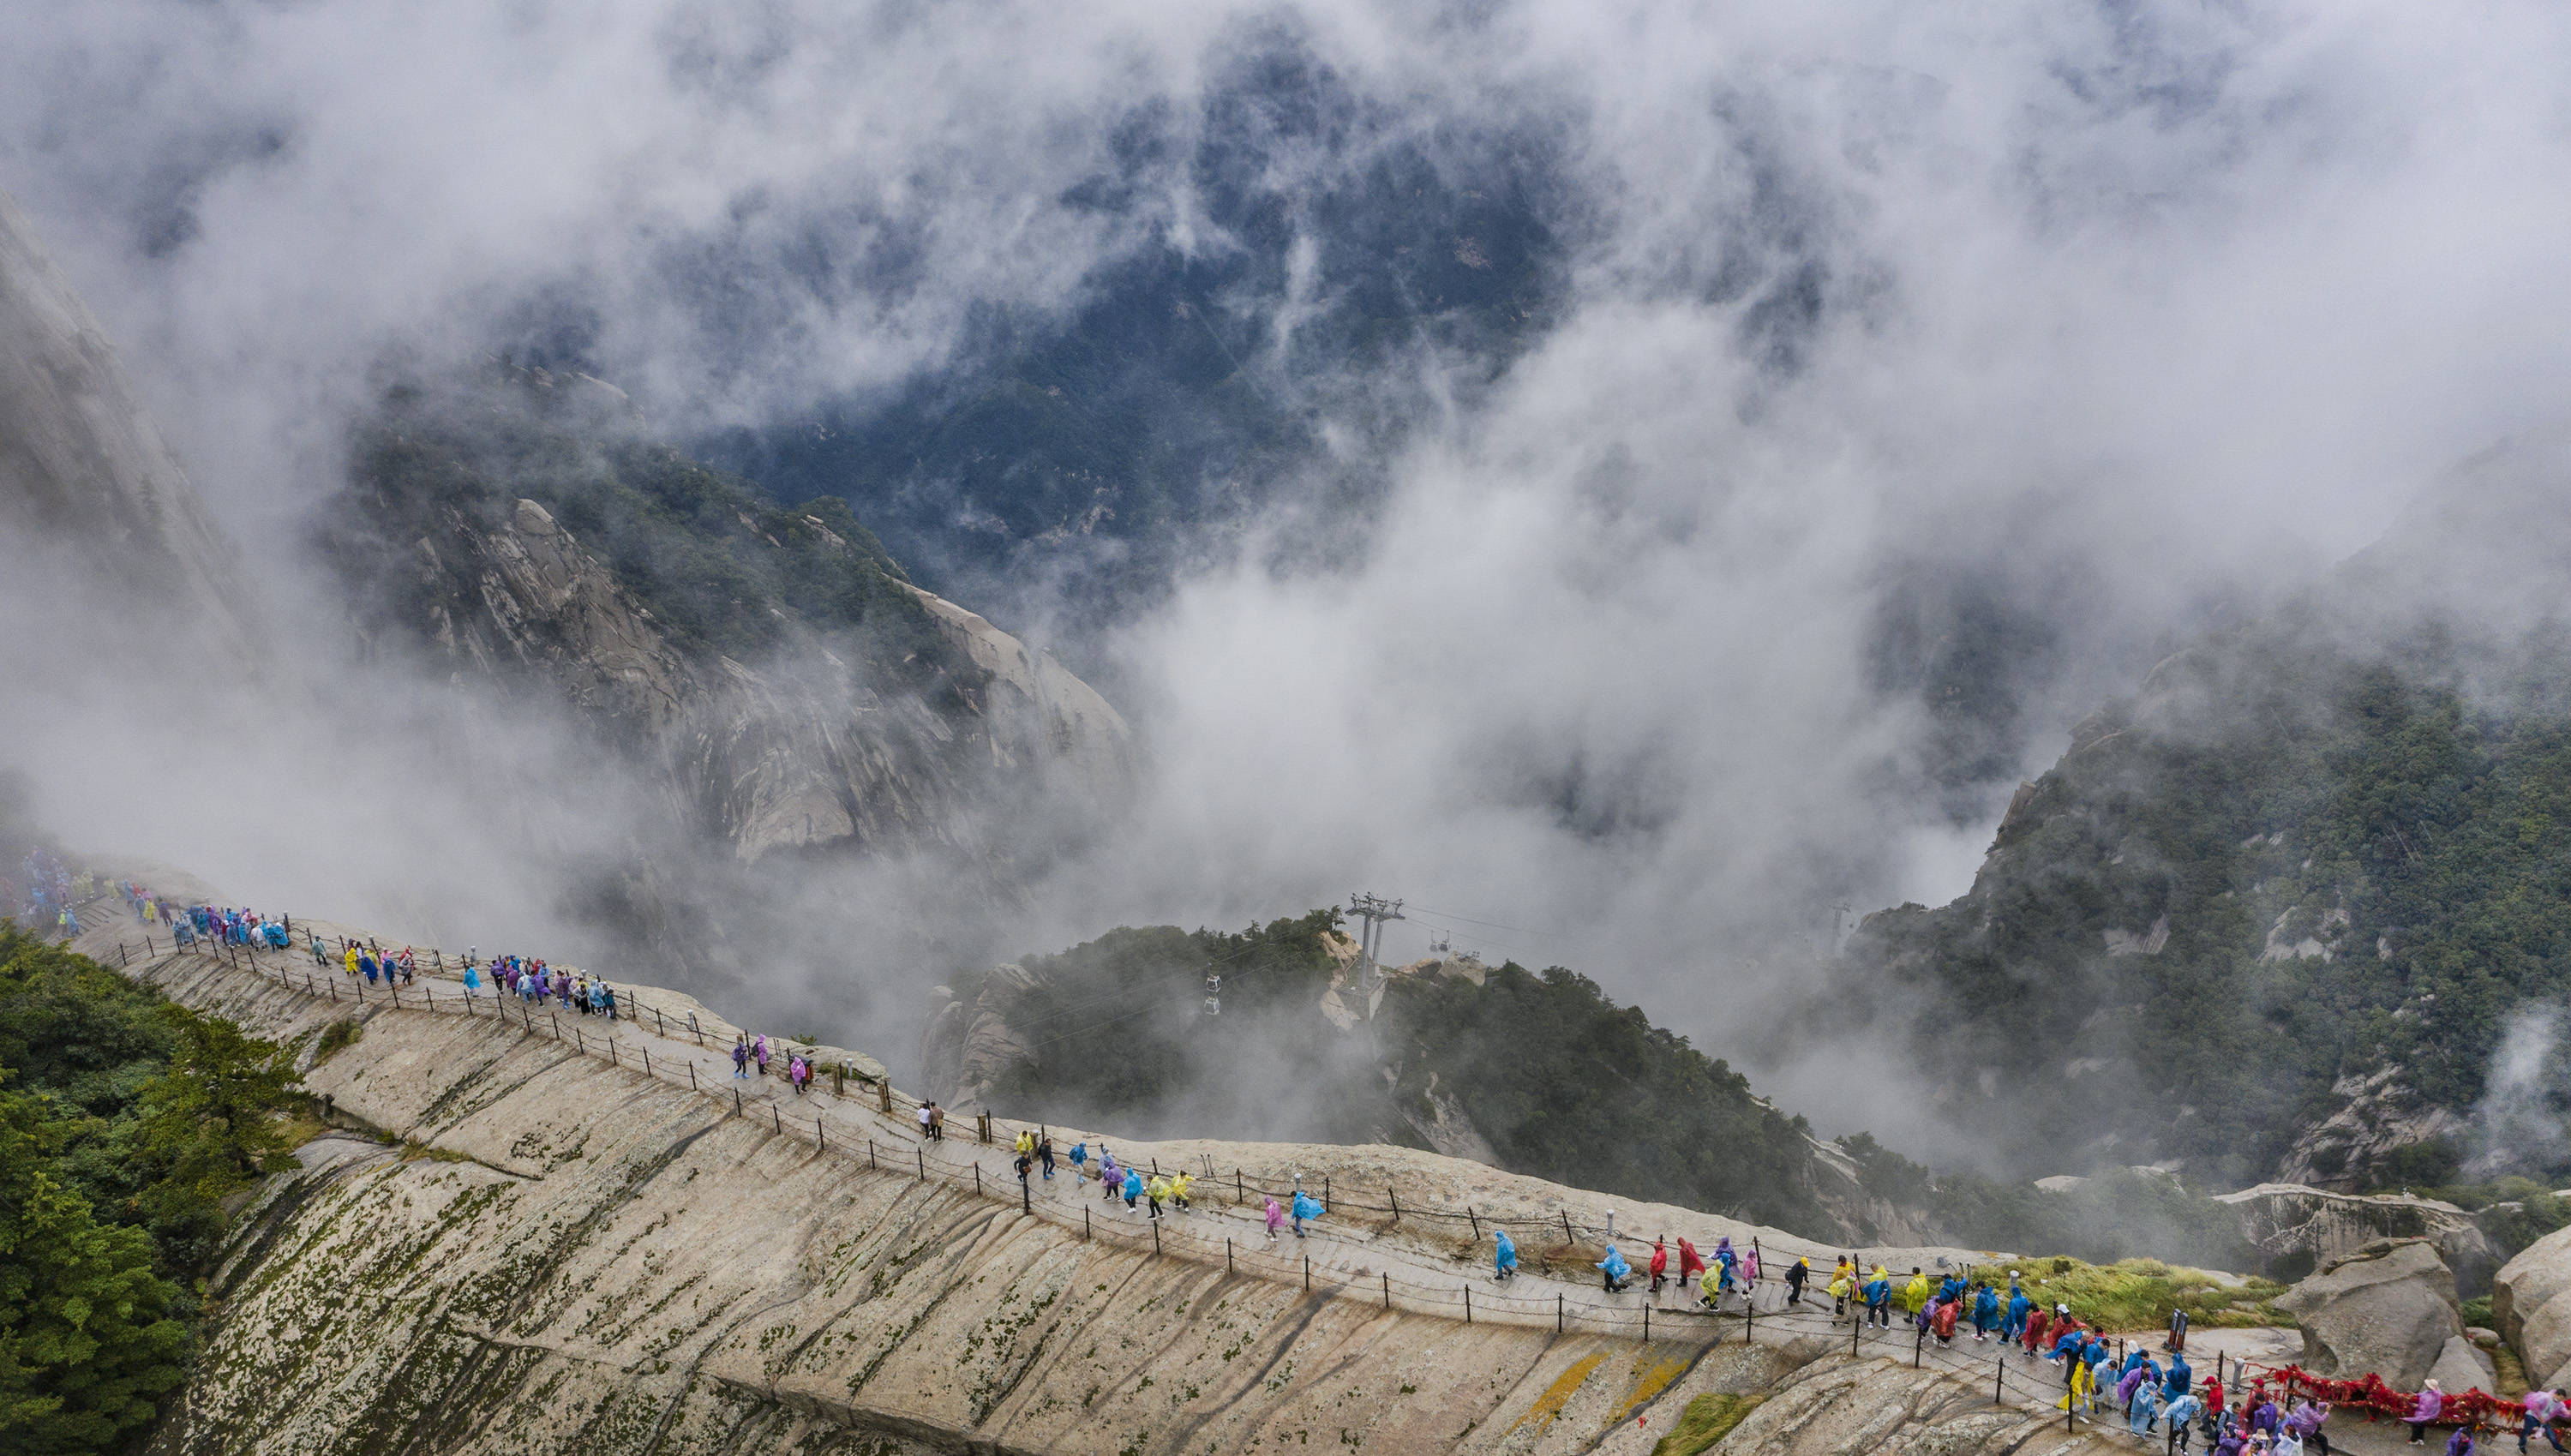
[{"left": 956, "top": 911, "right": 1820, "bottom": 1227}]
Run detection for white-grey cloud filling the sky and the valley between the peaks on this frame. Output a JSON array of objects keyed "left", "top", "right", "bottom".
[{"left": 0, "top": 0, "right": 2571, "bottom": 1147}]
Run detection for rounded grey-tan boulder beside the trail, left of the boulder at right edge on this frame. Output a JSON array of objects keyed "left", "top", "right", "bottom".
[{"left": 2278, "top": 1240, "right": 2463, "bottom": 1389}]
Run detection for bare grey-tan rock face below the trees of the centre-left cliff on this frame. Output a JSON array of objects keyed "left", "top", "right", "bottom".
[{"left": 417, "top": 499, "right": 1134, "bottom": 865}]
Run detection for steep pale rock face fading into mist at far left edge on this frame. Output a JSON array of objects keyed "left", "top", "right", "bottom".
[{"left": 0, "top": 193, "right": 249, "bottom": 650}]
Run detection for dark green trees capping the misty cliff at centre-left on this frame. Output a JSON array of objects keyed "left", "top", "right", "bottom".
[{"left": 329, "top": 370, "right": 980, "bottom": 689}]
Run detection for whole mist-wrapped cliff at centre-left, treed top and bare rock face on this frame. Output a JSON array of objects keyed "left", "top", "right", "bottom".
[{"left": 324, "top": 370, "right": 1134, "bottom": 880}]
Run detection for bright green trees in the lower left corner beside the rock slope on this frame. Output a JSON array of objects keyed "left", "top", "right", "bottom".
[{"left": 0, "top": 921, "right": 298, "bottom": 1453}]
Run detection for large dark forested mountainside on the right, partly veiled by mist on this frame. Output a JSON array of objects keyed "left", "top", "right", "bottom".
[{"left": 1849, "top": 607, "right": 2571, "bottom": 1183}]
